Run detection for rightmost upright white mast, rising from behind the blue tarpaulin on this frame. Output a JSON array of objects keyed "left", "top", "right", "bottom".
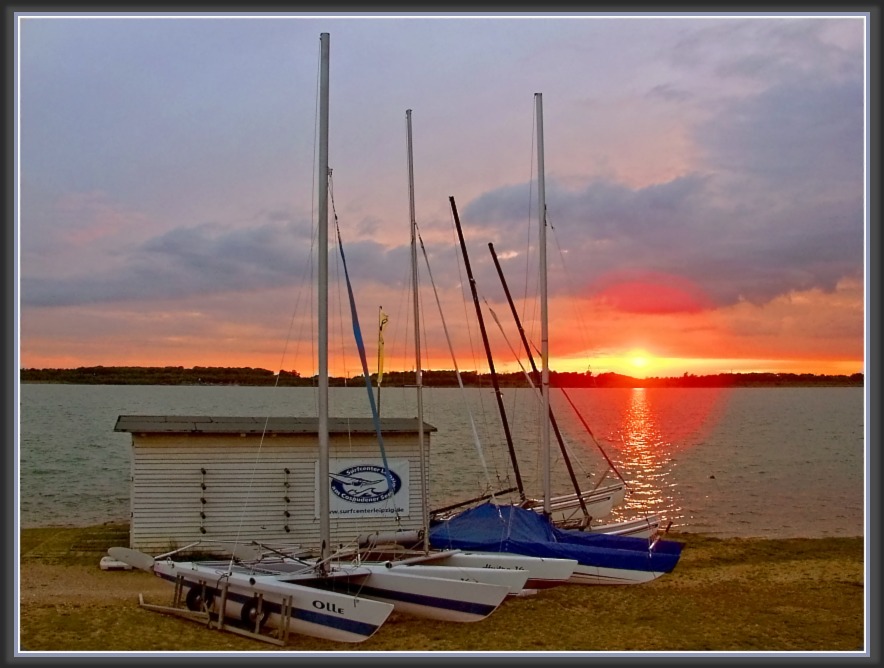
[{"left": 534, "top": 93, "right": 550, "bottom": 515}]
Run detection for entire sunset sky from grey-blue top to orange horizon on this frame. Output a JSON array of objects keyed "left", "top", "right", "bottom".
[{"left": 16, "top": 14, "right": 868, "bottom": 377}]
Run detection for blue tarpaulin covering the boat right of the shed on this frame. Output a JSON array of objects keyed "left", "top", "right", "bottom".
[{"left": 430, "top": 503, "right": 684, "bottom": 573}]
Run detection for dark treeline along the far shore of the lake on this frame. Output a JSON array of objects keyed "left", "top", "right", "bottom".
[{"left": 21, "top": 366, "right": 864, "bottom": 387}]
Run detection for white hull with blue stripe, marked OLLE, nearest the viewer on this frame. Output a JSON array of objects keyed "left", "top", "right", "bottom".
[{"left": 153, "top": 561, "right": 393, "bottom": 642}]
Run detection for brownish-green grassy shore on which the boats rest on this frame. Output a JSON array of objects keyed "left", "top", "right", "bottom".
[{"left": 20, "top": 525, "right": 865, "bottom": 652}]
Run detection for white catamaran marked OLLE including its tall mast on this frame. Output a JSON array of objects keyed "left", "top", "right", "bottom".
[{"left": 108, "top": 33, "right": 393, "bottom": 644}]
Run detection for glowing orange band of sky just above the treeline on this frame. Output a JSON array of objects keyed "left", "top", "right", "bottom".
[{"left": 21, "top": 272, "right": 864, "bottom": 378}]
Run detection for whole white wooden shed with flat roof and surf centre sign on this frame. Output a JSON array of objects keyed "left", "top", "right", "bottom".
[{"left": 114, "top": 415, "right": 436, "bottom": 554}]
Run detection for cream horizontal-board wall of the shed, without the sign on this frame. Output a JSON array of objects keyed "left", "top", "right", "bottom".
[{"left": 130, "top": 434, "right": 421, "bottom": 554}]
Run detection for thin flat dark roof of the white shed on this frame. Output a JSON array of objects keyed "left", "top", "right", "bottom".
[{"left": 114, "top": 415, "right": 436, "bottom": 434}]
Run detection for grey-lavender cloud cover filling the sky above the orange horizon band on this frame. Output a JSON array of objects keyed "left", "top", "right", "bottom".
[{"left": 21, "top": 18, "right": 864, "bottom": 370}]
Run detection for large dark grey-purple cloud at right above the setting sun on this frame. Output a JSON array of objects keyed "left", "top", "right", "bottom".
[{"left": 446, "top": 41, "right": 864, "bottom": 311}]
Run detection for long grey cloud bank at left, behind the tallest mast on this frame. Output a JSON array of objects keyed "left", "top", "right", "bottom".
[{"left": 22, "top": 201, "right": 410, "bottom": 306}]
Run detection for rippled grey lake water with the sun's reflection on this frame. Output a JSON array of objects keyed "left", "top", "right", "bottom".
[{"left": 17, "top": 384, "right": 867, "bottom": 538}]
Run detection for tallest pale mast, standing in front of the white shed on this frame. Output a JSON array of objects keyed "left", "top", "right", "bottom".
[{"left": 317, "top": 32, "right": 331, "bottom": 573}]
